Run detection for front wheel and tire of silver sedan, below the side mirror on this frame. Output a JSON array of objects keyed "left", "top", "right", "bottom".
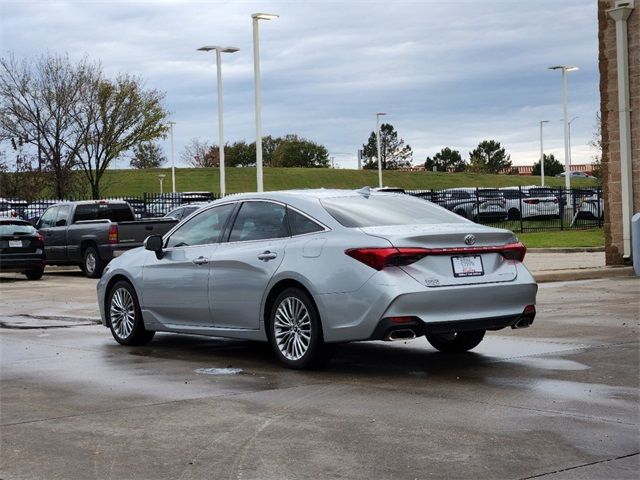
[{"left": 105, "top": 280, "right": 156, "bottom": 345}]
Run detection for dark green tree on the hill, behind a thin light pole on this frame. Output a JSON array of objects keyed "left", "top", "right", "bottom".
[{"left": 362, "top": 123, "right": 413, "bottom": 170}]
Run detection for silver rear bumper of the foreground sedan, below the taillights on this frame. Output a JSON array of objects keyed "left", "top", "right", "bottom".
[{"left": 315, "top": 264, "right": 538, "bottom": 342}]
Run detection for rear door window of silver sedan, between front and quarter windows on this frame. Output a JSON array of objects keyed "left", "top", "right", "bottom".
[{"left": 229, "top": 202, "right": 289, "bottom": 242}]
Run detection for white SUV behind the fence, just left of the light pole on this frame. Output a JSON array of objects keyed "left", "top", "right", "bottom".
[{"left": 500, "top": 186, "right": 560, "bottom": 220}]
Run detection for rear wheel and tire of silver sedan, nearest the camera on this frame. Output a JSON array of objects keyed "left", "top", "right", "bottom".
[{"left": 268, "top": 288, "right": 333, "bottom": 370}]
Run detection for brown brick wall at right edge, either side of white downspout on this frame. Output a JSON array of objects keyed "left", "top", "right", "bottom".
[{"left": 598, "top": 0, "right": 640, "bottom": 265}]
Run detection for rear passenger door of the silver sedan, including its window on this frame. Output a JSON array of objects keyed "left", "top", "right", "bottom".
[{"left": 211, "top": 201, "right": 289, "bottom": 329}]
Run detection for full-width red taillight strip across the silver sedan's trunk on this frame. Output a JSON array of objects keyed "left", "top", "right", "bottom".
[{"left": 344, "top": 242, "right": 527, "bottom": 270}]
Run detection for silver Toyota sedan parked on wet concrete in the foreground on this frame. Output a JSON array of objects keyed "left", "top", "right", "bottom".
[{"left": 98, "top": 188, "right": 537, "bottom": 368}]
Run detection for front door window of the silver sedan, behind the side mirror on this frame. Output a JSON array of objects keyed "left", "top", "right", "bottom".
[{"left": 167, "top": 204, "right": 234, "bottom": 248}]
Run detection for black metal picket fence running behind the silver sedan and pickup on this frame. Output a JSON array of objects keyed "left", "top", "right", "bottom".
[{"left": 0, "top": 187, "right": 604, "bottom": 232}]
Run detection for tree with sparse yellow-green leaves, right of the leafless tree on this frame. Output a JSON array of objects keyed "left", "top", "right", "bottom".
[{"left": 75, "top": 71, "right": 168, "bottom": 198}]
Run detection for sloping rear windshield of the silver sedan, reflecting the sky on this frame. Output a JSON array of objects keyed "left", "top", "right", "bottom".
[{"left": 320, "top": 195, "right": 465, "bottom": 228}]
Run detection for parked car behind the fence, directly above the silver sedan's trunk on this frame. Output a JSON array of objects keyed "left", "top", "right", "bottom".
[{"left": 432, "top": 188, "right": 507, "bottom": 222}]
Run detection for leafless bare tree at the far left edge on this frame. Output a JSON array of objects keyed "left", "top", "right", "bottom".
[{"left": 0, "top": 54, "right": 92, "bottom": 198}]
